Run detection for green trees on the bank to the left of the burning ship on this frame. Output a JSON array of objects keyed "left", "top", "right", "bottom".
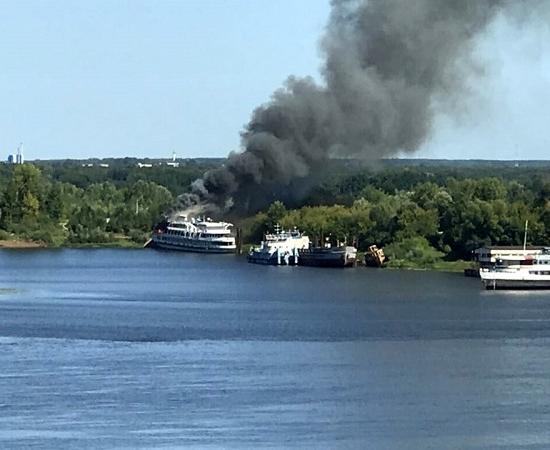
[{"left": 0, "top": 160, "right": 220, "bottom": 246}]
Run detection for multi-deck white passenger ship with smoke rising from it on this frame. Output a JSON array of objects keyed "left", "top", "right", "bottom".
[{"left": 152, "top": 216, "right": 237, "bottom": 253}]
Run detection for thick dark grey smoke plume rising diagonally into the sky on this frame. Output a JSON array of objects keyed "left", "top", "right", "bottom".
[{"left": 180, "top": 0, "right": 528, "bottom": 216}]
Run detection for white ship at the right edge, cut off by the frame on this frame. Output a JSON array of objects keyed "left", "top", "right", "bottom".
[{"left": 479, "top": 247, "right": 550, "bottom": 289}]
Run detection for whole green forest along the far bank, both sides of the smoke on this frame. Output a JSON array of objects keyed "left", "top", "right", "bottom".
[{"left": 0, "top": 160, "right": 550, "bottom": 266}]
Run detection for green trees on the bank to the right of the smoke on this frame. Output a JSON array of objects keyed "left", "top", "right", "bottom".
[{"left": 248, "top": 167, "right": 550, "bottom": 265}]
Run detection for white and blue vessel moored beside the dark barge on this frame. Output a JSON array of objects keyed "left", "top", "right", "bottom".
[{"left": 248, "top": 226, "right": 309, "bottom": 266}]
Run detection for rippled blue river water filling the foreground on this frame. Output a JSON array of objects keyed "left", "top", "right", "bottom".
[{"left": 0, "top": 249, "right": 550, "bottom": 450}]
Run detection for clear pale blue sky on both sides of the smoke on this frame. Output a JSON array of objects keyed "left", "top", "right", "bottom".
[{"left": 0, "top": 0, "right": 550, "bottom": 160}]
